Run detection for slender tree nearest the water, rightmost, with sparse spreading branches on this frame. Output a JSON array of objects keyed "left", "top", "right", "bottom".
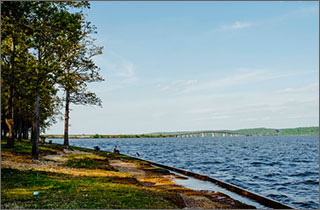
[{"left": 59, "top": 9, "right": 104, "bottom": 149}]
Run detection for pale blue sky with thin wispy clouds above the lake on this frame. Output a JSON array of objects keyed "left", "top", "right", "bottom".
[{"left": 46, "top": 1, "right": 319, "bottom": 134}]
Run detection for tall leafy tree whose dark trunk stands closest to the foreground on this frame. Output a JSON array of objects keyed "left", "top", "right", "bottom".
[{"left": 25, "top": 2, "right": 61, "bottom": 159}]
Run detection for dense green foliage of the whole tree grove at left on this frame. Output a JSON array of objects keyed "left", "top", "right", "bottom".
[{"left": 1, "top": 1, "right": 102, "bottom": 158}]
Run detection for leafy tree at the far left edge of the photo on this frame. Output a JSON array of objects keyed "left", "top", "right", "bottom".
[{"left": 1, "top": 2, "right": 30, "bottom": 147}]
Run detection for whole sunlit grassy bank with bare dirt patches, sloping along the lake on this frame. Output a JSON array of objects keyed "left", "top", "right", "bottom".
[{"left": 1, "top": 140, "right": 254, "bottom": 209}]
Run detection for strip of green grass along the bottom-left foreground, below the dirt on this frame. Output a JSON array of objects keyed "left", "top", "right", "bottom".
[{"left": 1, "top": 168, "right": 178, "bottom": 209}]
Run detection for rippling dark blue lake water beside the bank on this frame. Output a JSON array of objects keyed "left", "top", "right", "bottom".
[{"left": 53, "top": 136, "right": 319, "bottom": 209}]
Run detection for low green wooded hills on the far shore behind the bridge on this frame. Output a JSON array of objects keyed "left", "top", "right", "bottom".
[{"left": 149, "top": 126, "right": 319, "bottom": 136}]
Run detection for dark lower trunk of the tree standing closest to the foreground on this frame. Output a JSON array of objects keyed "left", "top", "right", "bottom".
[{"left": 32, "top": 93, "right": 40, "bottom": 159}]
